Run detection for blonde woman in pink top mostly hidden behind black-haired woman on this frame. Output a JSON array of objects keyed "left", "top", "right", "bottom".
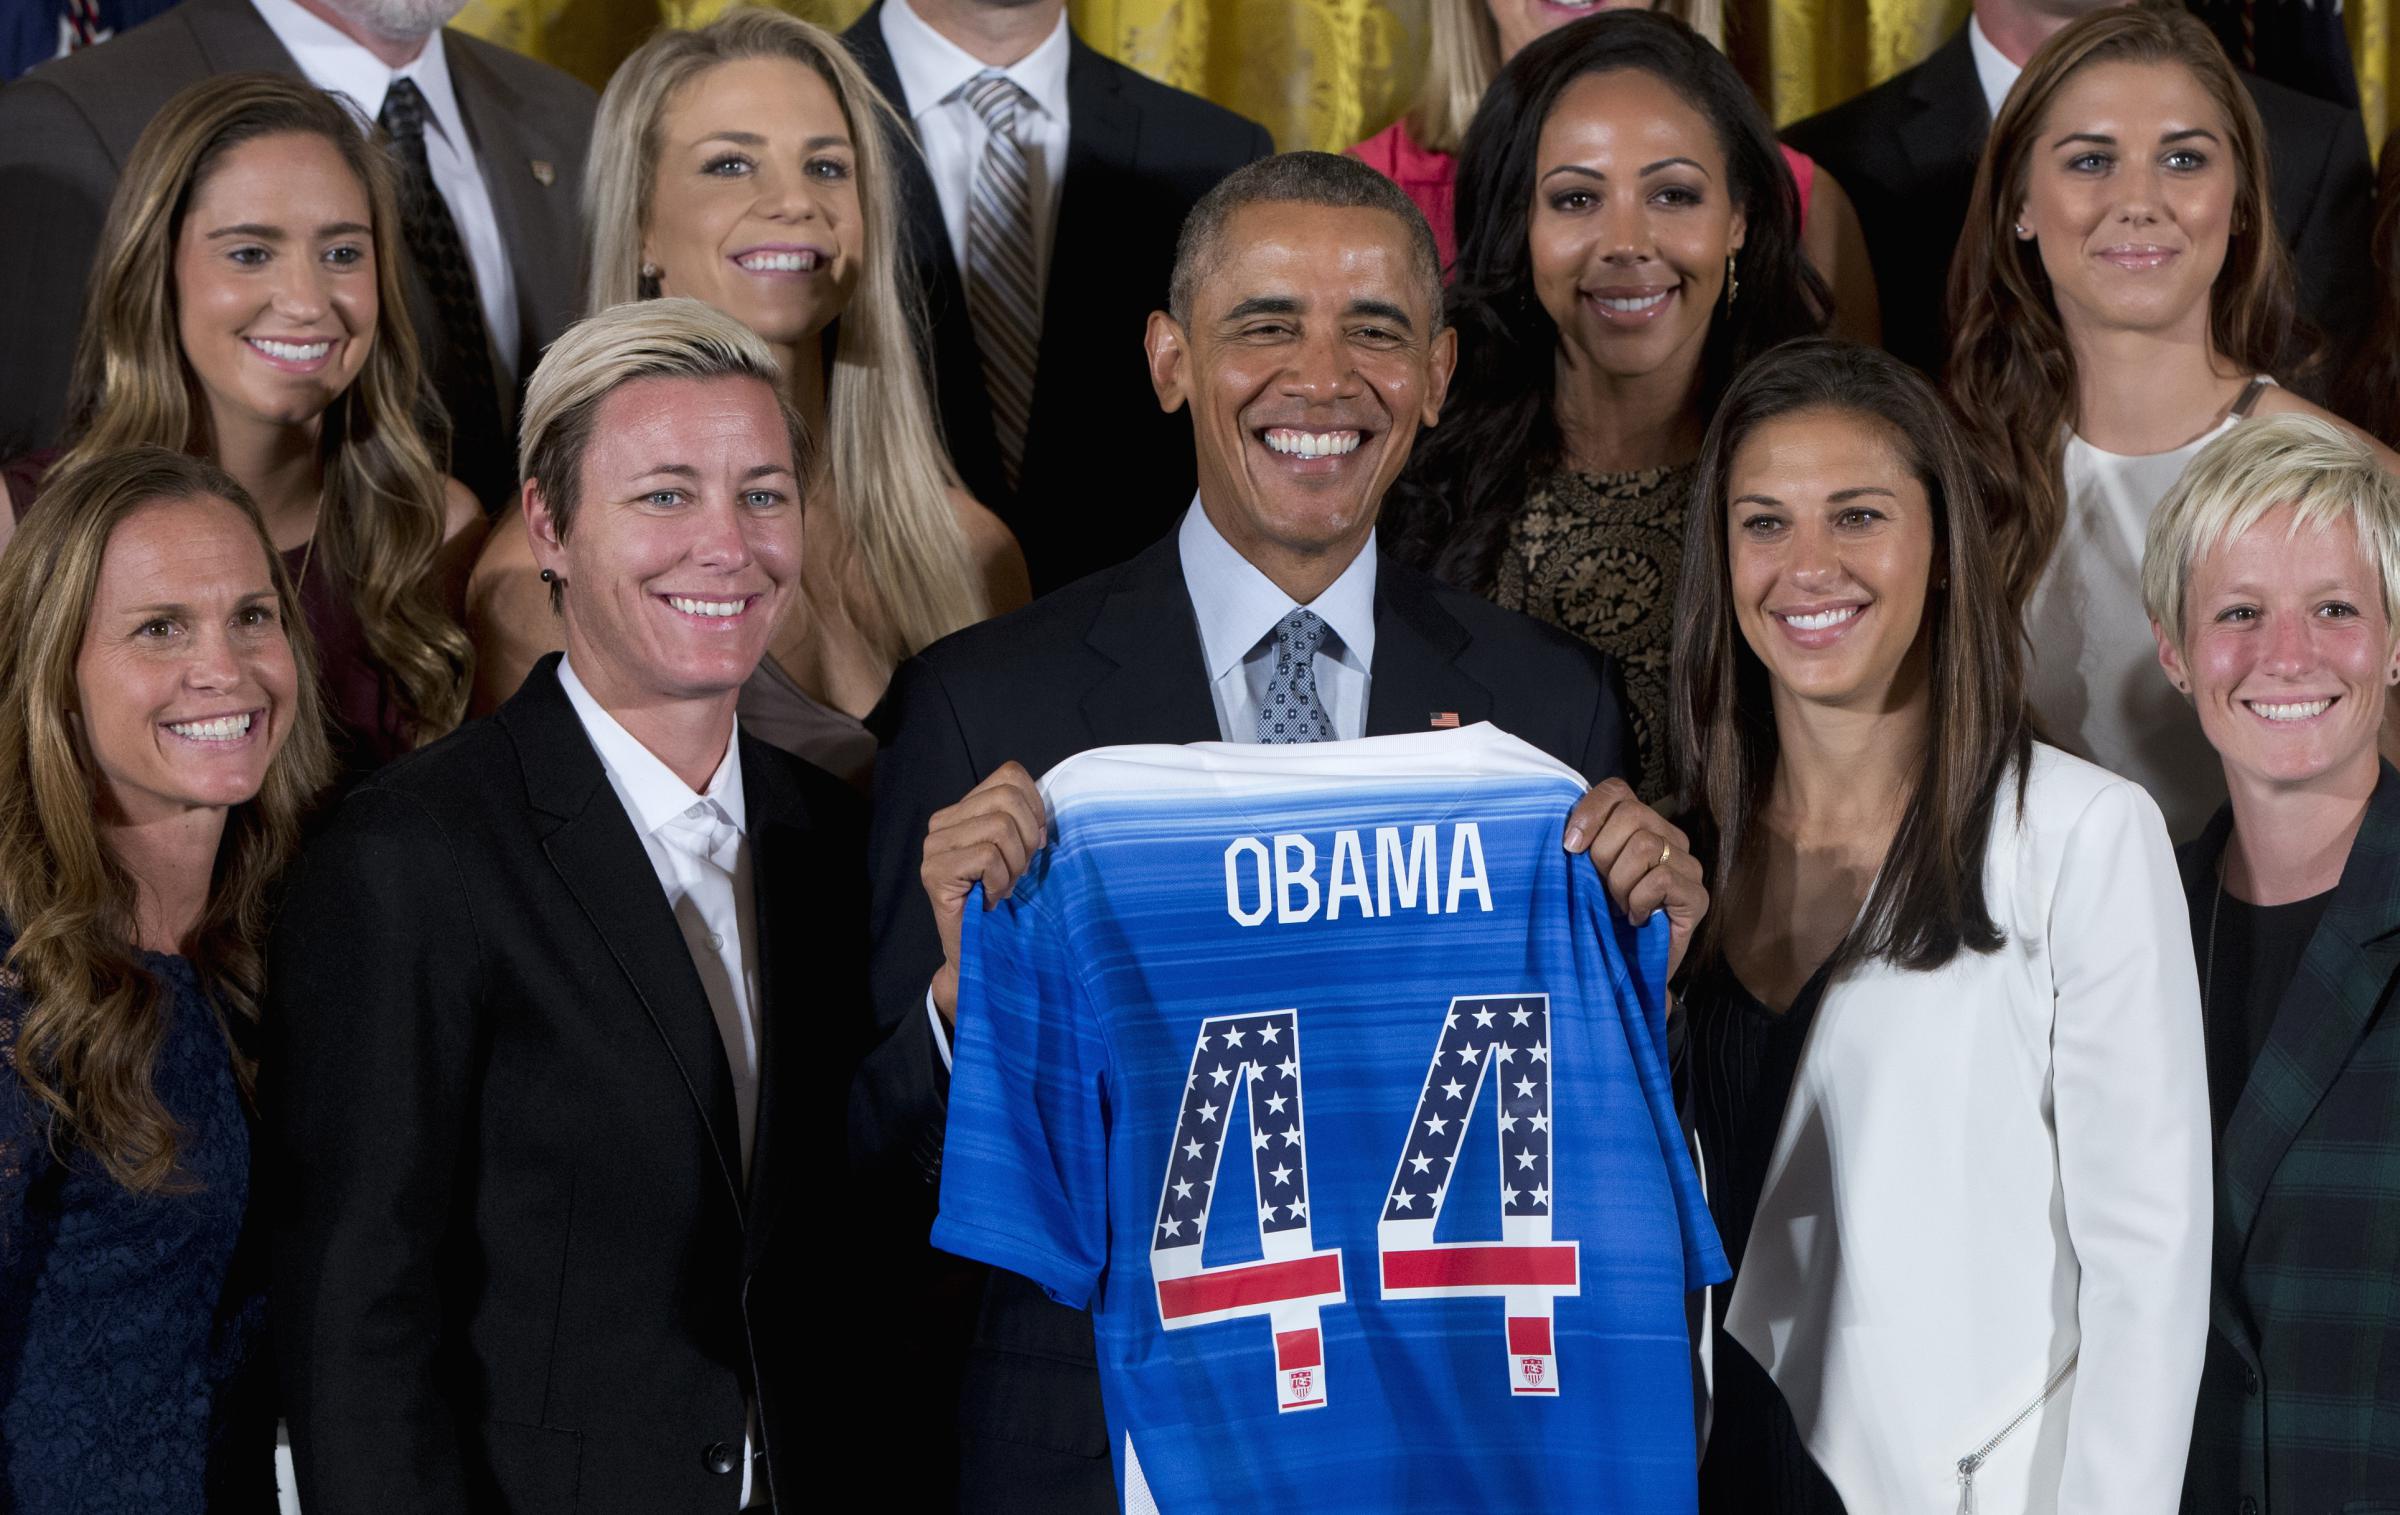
[{"left": 1349, "top": 0, "right": 1882, "bottom": 341}]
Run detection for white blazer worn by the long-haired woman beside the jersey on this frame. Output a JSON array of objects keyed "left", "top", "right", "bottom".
[{"left": 1726, "top": 747, "right": 2210, "bottom": 1515}]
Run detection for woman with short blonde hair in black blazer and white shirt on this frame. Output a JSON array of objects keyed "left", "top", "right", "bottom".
[{"left": 266, "top": 300, "right": 866, "bottom": 1515}]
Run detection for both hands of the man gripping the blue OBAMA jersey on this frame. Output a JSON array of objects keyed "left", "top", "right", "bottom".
[{"left": 917, "top": 764, "right": 1709, "bottom": 1023}]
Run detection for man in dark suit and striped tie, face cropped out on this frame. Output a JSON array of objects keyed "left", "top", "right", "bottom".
[{"left": 842, "top": 0, "right": 1274, "bottom": 593}]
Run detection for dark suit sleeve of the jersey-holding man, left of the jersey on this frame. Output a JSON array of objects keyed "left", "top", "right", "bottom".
[{"left": 850, "top": 658, "right": 979, "bottom": 1205}]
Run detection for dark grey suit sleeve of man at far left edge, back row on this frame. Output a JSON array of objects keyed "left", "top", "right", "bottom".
[{"left": 0, "top": 77, "right": 118, "bottom": 459}]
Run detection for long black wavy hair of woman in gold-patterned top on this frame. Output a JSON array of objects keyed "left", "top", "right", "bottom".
[{"left": 1385, "top": 10, "right": 1834, "bottom": 588}]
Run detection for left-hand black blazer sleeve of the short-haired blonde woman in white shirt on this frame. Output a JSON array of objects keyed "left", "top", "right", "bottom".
[{"left": 262, "top": 785, "right": 482, "bottom": 1515}]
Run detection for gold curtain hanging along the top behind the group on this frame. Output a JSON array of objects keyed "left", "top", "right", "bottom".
[{"left": 458, "top": 0, "right": 2400, "bottom": 149}]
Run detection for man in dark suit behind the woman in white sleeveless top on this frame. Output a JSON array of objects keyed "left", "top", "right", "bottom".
[{"left": 1783, "top": 0, "right": 2376, "bottom": 375}]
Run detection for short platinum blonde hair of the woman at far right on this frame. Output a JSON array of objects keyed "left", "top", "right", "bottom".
[{"left": 2141, "top": 415, "right": 2400, "bottom": 646}]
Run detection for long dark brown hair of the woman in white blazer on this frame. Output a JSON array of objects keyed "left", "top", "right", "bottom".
[{"left": 1668, "top": 339, "right": 2033, "bottom": 970}]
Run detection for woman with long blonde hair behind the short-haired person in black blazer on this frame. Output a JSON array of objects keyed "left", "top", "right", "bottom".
[{"left": 470, "top": 7, "right": 1030, "bottom": 783}]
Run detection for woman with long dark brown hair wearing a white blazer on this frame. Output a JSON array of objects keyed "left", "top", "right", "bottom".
[{"left": 1673, "top": 341, "right": 2210, "bottom": 1515}]
